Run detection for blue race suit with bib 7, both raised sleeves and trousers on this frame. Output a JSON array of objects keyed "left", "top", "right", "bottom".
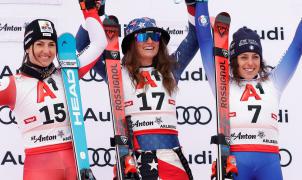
[{"left": 196, "top": 0, "right": 302, "bottom": 180}]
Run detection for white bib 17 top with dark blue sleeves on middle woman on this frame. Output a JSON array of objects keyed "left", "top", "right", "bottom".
[{"left": 76, "top": 6, "right": 198, "bottom": 150}]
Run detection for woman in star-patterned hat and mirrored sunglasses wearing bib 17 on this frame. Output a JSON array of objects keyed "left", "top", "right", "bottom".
[{"left": 78, "top": 0, "right": 198, "bottom": 180}]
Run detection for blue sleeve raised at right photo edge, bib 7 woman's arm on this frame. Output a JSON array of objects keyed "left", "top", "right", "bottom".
[{"left": 270, "top": 20, "right": 302, "bottom": 92}]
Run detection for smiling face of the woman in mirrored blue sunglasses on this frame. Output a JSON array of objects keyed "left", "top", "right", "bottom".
[{"left": 135, "top": 34, "right": 159, "bottom": 66}]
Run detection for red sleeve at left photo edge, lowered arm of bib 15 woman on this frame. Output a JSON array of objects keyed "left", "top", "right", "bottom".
[{"left": 0, "top": 76, "right": 16, "bottom": 110}]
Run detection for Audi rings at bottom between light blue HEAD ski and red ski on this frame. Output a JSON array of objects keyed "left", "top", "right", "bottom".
[{"left": 88, "top": 148, "right": 115, "bottom": 167}]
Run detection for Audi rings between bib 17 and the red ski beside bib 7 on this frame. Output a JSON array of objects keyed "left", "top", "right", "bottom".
[{"left": 176, "top": 106, "right": 212, "bottom": 125}]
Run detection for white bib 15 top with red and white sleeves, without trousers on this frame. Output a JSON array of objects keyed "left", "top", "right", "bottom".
[{"left": 0, "top": 10, "right": 107, "bottom": 152}]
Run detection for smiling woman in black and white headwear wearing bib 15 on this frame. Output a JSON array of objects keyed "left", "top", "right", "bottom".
[{"left": 0, "top": 1, "right": 107, "bottom": 180}]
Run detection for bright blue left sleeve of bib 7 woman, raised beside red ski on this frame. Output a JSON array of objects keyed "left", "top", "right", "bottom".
[{"left": 195, "top": 2, "right": 215, "bottom": 94}]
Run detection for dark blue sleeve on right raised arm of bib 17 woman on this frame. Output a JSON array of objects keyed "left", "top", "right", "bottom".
[{"left": 171, "top": 23, "right": 198, "bottom": 83}]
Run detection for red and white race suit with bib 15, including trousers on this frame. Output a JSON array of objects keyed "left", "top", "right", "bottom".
[{"left": 0, "top": 10, "right": 107, "bottom": 180}]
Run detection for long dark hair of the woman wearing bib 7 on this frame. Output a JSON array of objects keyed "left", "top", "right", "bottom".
[{"left": 230, "top": 57, "right": 268, "bottom": 85}]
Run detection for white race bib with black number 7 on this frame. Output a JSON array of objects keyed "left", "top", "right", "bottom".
[{"left": 230, "top": 80, "right": 280, "bottom": 152}]
